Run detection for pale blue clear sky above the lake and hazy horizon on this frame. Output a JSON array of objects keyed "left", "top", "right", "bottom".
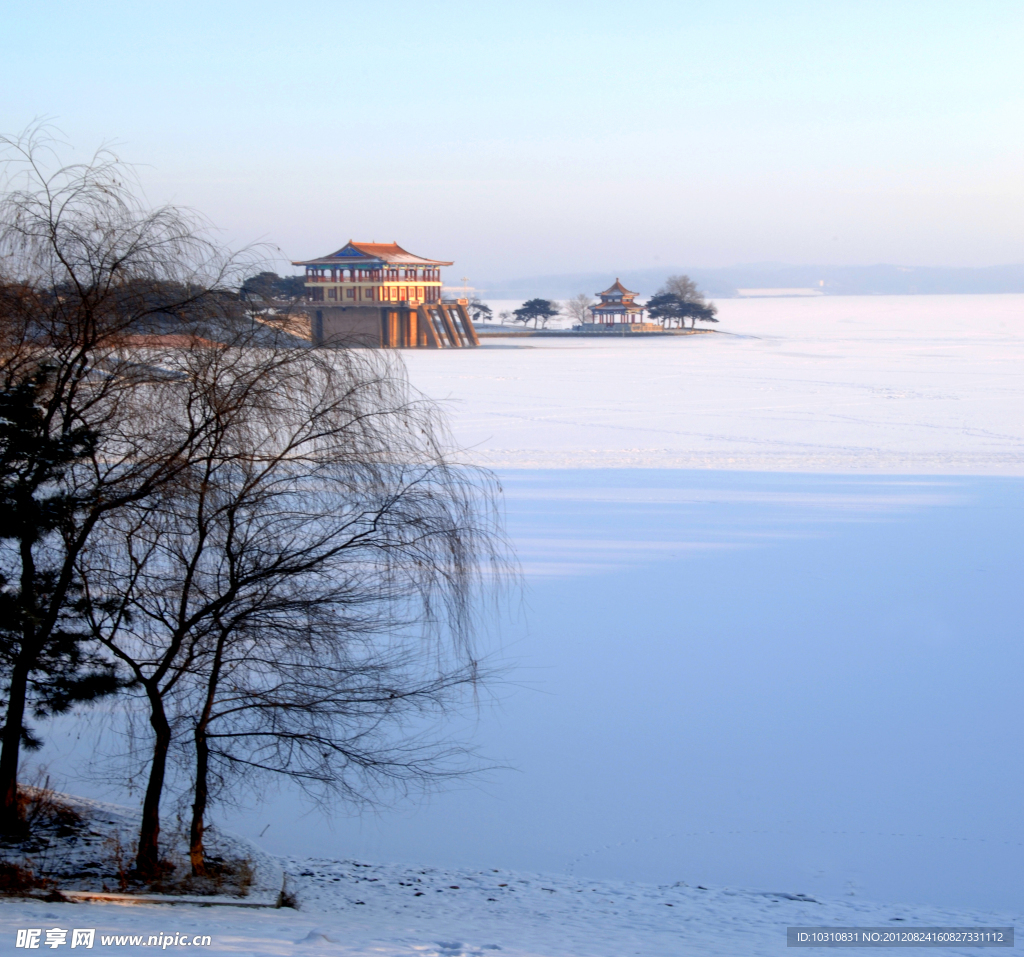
[{"left": 0, "top": 0, "right": 1024, "bottom": 281}]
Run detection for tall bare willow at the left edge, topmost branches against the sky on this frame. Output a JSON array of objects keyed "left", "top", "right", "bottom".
[{"left": 0, "top": 127, "right": 258, "bottom": 832}]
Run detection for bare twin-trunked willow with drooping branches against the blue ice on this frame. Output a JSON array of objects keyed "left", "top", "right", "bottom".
[{"left": 79, "top": 315, "right": 505, "bottom": 875}]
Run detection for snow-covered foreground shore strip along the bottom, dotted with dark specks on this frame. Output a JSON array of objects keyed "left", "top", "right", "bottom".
[{"left": 0, "top": 858, "right": 1019, "bottom": 957}]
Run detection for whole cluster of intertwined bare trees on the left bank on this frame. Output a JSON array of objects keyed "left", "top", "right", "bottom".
[{"left": 0, "top": 130, "right": 509, "bottom": 880}]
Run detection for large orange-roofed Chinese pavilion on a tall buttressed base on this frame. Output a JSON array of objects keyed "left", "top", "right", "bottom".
[{"left": 292, "top": 241, "right": 480, "bottom": 349}]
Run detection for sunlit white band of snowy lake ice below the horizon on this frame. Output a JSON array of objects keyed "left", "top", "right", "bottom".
[{"left": 403, "top": 295, "right": 1024, "bottom": 475}]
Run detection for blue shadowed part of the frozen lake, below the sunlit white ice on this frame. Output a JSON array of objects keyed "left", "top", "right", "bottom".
[{"left": 203, "top": 470, "right": 1024, "bottom": 909}]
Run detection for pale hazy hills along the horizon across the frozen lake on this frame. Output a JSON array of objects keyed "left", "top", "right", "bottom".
[{"left": 477, "top": 263, "right": 1024, "bottom": 299}]
